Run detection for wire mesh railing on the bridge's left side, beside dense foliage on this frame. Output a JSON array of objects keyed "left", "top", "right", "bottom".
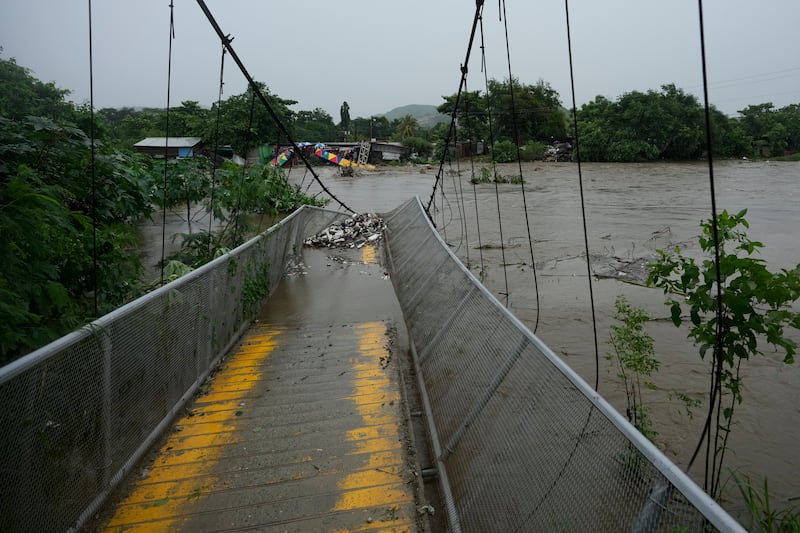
[{"left": 0, "top": 207, "right": 344, "bottom": 532}]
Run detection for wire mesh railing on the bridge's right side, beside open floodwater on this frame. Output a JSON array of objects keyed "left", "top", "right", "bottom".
[{"left": 385, "top": 199, "right": 743, "bottom": 532}]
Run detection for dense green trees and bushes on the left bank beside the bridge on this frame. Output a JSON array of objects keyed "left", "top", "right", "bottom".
[{"left": 0, "top": 58, "right": 322, "bottom": 365}]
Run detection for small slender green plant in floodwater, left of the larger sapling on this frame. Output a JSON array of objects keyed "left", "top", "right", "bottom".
[{"left": 606, "top": 295, "right": 660, "bottom": 440}]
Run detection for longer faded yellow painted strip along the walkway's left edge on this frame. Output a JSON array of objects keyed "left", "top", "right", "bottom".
[{"left": 106, "top": 329, "right": 280, "bottom": 532}]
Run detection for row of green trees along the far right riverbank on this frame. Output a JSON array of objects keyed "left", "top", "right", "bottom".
[{"left": 437, "top": 79, "right": 800, "bottom": 163}]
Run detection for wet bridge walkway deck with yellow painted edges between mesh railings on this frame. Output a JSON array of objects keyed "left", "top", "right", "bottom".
[{"left": 97, "top": 246, "right": 418, "bottom": 532}]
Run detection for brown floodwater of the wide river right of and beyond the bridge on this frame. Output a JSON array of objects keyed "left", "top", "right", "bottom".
[{"left": 290, "top": 160, "right": 800, "bottom": 509}]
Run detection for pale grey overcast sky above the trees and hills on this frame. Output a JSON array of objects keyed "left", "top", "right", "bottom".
[{"left": 0, "top": 0, "right": 800, "bottom": 122}]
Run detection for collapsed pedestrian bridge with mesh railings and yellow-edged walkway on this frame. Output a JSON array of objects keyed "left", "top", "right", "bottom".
[{"left": 0, "top": 199, "right": 742, "bottom": 531}]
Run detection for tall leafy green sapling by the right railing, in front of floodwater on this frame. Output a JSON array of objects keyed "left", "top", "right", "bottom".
[{"left": 647, "top": 210, "right": 800, "bottom": 496}]
